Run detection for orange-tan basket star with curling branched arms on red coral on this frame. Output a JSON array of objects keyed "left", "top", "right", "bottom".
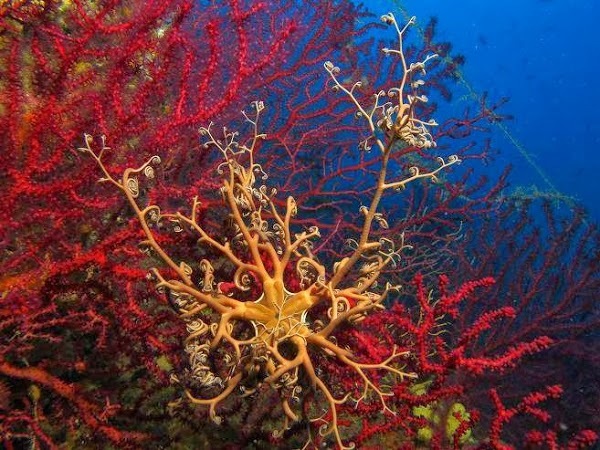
[{"left": 80, "top": 13, "right": 458, "bottom": 449}]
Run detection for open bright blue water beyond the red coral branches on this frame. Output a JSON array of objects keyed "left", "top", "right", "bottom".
[{"left": 367, "top": 0, "right": 600, "bottom": 221}]
